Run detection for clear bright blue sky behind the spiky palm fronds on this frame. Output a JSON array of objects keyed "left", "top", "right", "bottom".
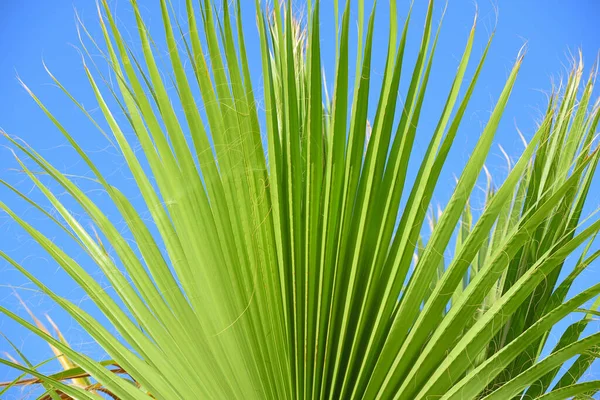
[{"left": 0, "top": 0, "right": 600, "bottom": 398}]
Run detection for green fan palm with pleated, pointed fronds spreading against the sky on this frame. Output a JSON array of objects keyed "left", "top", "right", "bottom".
[{"left": 0, "top": 0, "right": 600, "bottom": 400}]
